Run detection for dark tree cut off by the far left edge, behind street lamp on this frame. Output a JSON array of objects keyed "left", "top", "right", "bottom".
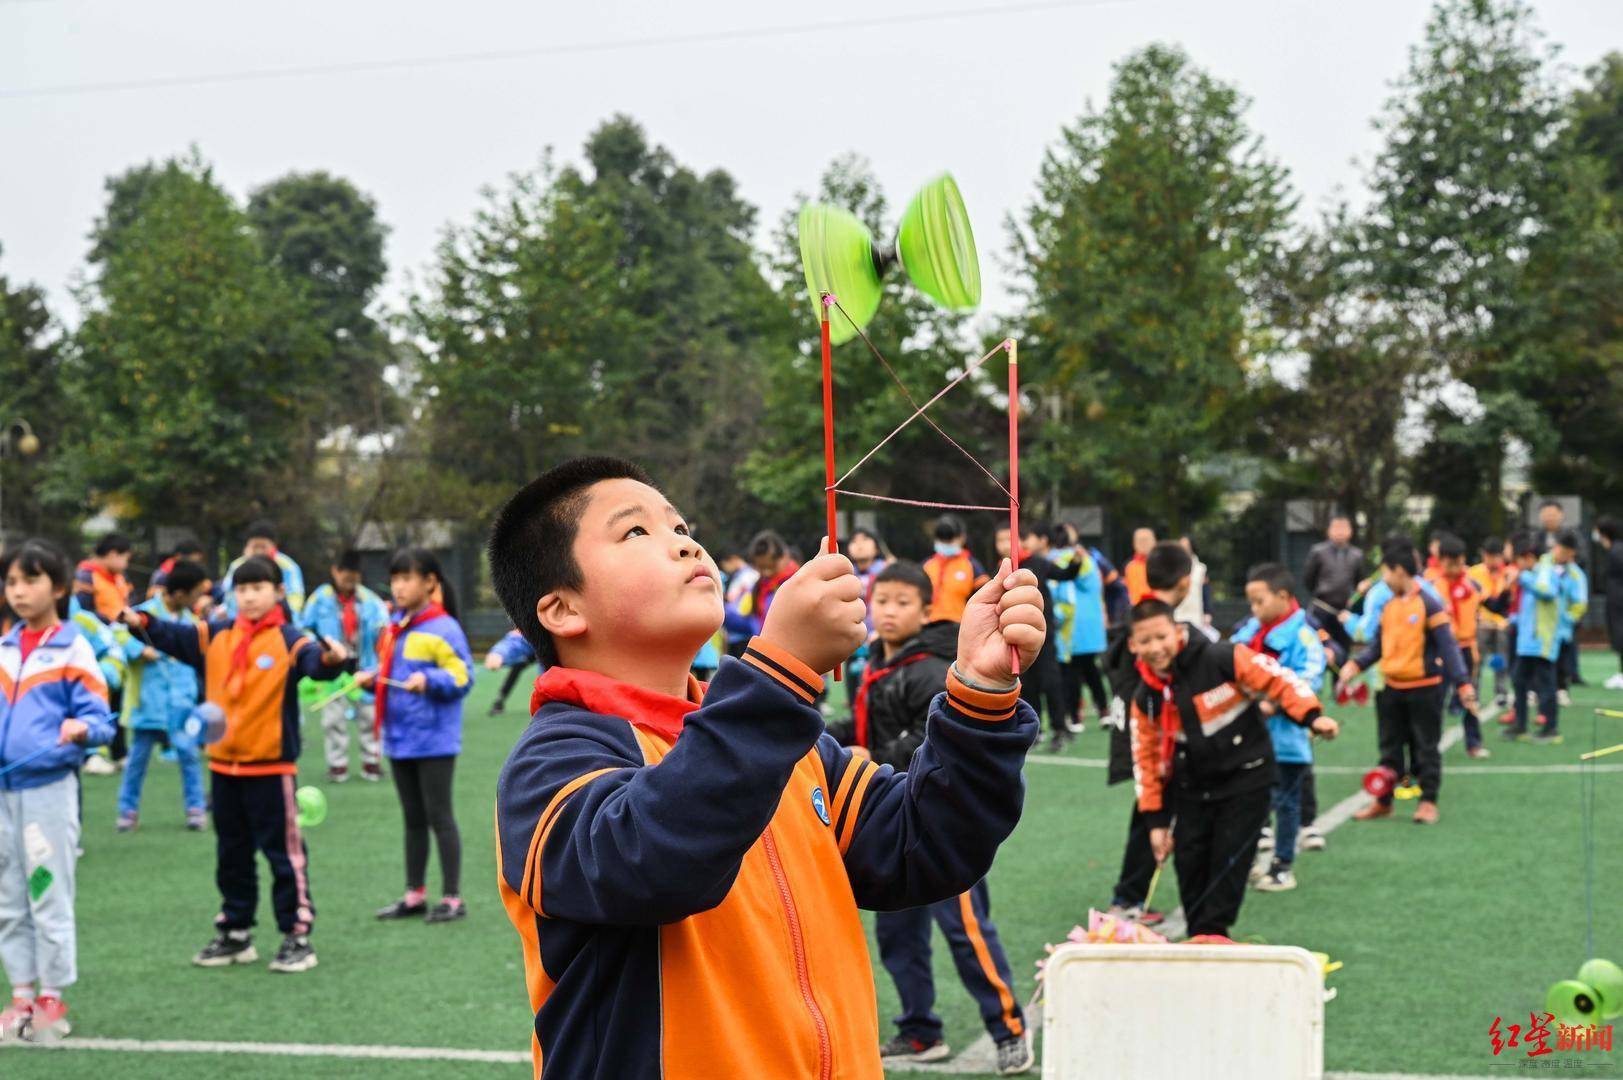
[{"left": 0, "top": 246, "right": 83, "bottom": 541}]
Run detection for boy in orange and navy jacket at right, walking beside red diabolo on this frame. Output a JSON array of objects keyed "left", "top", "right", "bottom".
[{"left": 1341, "top": 544, "right": 1477, "bottom": 825}]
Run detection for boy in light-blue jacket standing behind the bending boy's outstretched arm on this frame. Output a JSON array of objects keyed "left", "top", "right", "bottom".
[{"left": 1233, "top": 562, "right": 1324, "bottom": 892}]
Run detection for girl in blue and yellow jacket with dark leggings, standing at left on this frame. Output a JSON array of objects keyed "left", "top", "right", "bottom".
[{"left": 355, "top": 547, "right": 474, "bottom": 922}]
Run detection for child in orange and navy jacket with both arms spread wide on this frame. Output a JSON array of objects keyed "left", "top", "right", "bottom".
[{"left": 122, "top": 555, "right": 354, "bottom": 971}]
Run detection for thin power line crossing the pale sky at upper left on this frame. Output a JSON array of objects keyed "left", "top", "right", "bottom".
[{"left": 0, "top": 0, "right": 1134, "bottom": 99}]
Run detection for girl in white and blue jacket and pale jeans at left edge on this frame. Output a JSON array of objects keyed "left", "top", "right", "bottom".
[{"left": 0, "top": 541, "right": 114, "bottom": 1043}]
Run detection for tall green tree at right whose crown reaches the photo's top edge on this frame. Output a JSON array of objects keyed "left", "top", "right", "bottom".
[{"left": 1370, "top": 0, "right": 1563, "bottom": 528}]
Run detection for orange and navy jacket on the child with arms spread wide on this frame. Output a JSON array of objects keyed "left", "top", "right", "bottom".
[{"left": 144, "top": 617, "right": 355, "bottom": 776}]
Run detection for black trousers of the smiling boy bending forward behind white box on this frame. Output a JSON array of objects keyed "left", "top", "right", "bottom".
[{"left": 1172, "top": 786, "right": 1274, "bottom": 937}]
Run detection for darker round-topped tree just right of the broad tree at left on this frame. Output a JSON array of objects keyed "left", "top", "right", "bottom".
[{"left": 248, "top": 172, "right": 393, "bottom": 432}]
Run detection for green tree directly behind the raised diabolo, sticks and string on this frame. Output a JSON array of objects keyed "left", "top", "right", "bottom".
[{"left": 740, "top": 156, "right": 1006, "bottom": 549}]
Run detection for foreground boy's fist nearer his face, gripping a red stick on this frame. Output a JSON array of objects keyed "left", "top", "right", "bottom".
[{"left": 761, "top": 536, "right": 868, "bottom": 672}]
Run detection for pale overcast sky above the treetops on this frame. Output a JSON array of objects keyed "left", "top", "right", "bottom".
[{"left": 0, "top": 0, "right": 1623, "bottom": 328}]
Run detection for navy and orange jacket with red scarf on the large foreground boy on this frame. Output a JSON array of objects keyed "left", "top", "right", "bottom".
[{"left": 497, "top": 638, "right": 1037, "bottom": 1080}]
